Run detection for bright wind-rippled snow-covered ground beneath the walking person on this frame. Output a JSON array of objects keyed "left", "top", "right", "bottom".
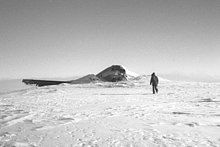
[{"left": 0, "top": 79, "right": 220, "bottom": 147}]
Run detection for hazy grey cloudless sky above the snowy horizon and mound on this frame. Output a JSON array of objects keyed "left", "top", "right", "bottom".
[{"left": 0, "top": 0, "right": 220, "bottom": 78}]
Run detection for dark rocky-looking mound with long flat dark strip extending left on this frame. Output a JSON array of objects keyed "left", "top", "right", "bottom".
[{"left": 22, "top": 65, "right": 127, "bottom": 86}]
